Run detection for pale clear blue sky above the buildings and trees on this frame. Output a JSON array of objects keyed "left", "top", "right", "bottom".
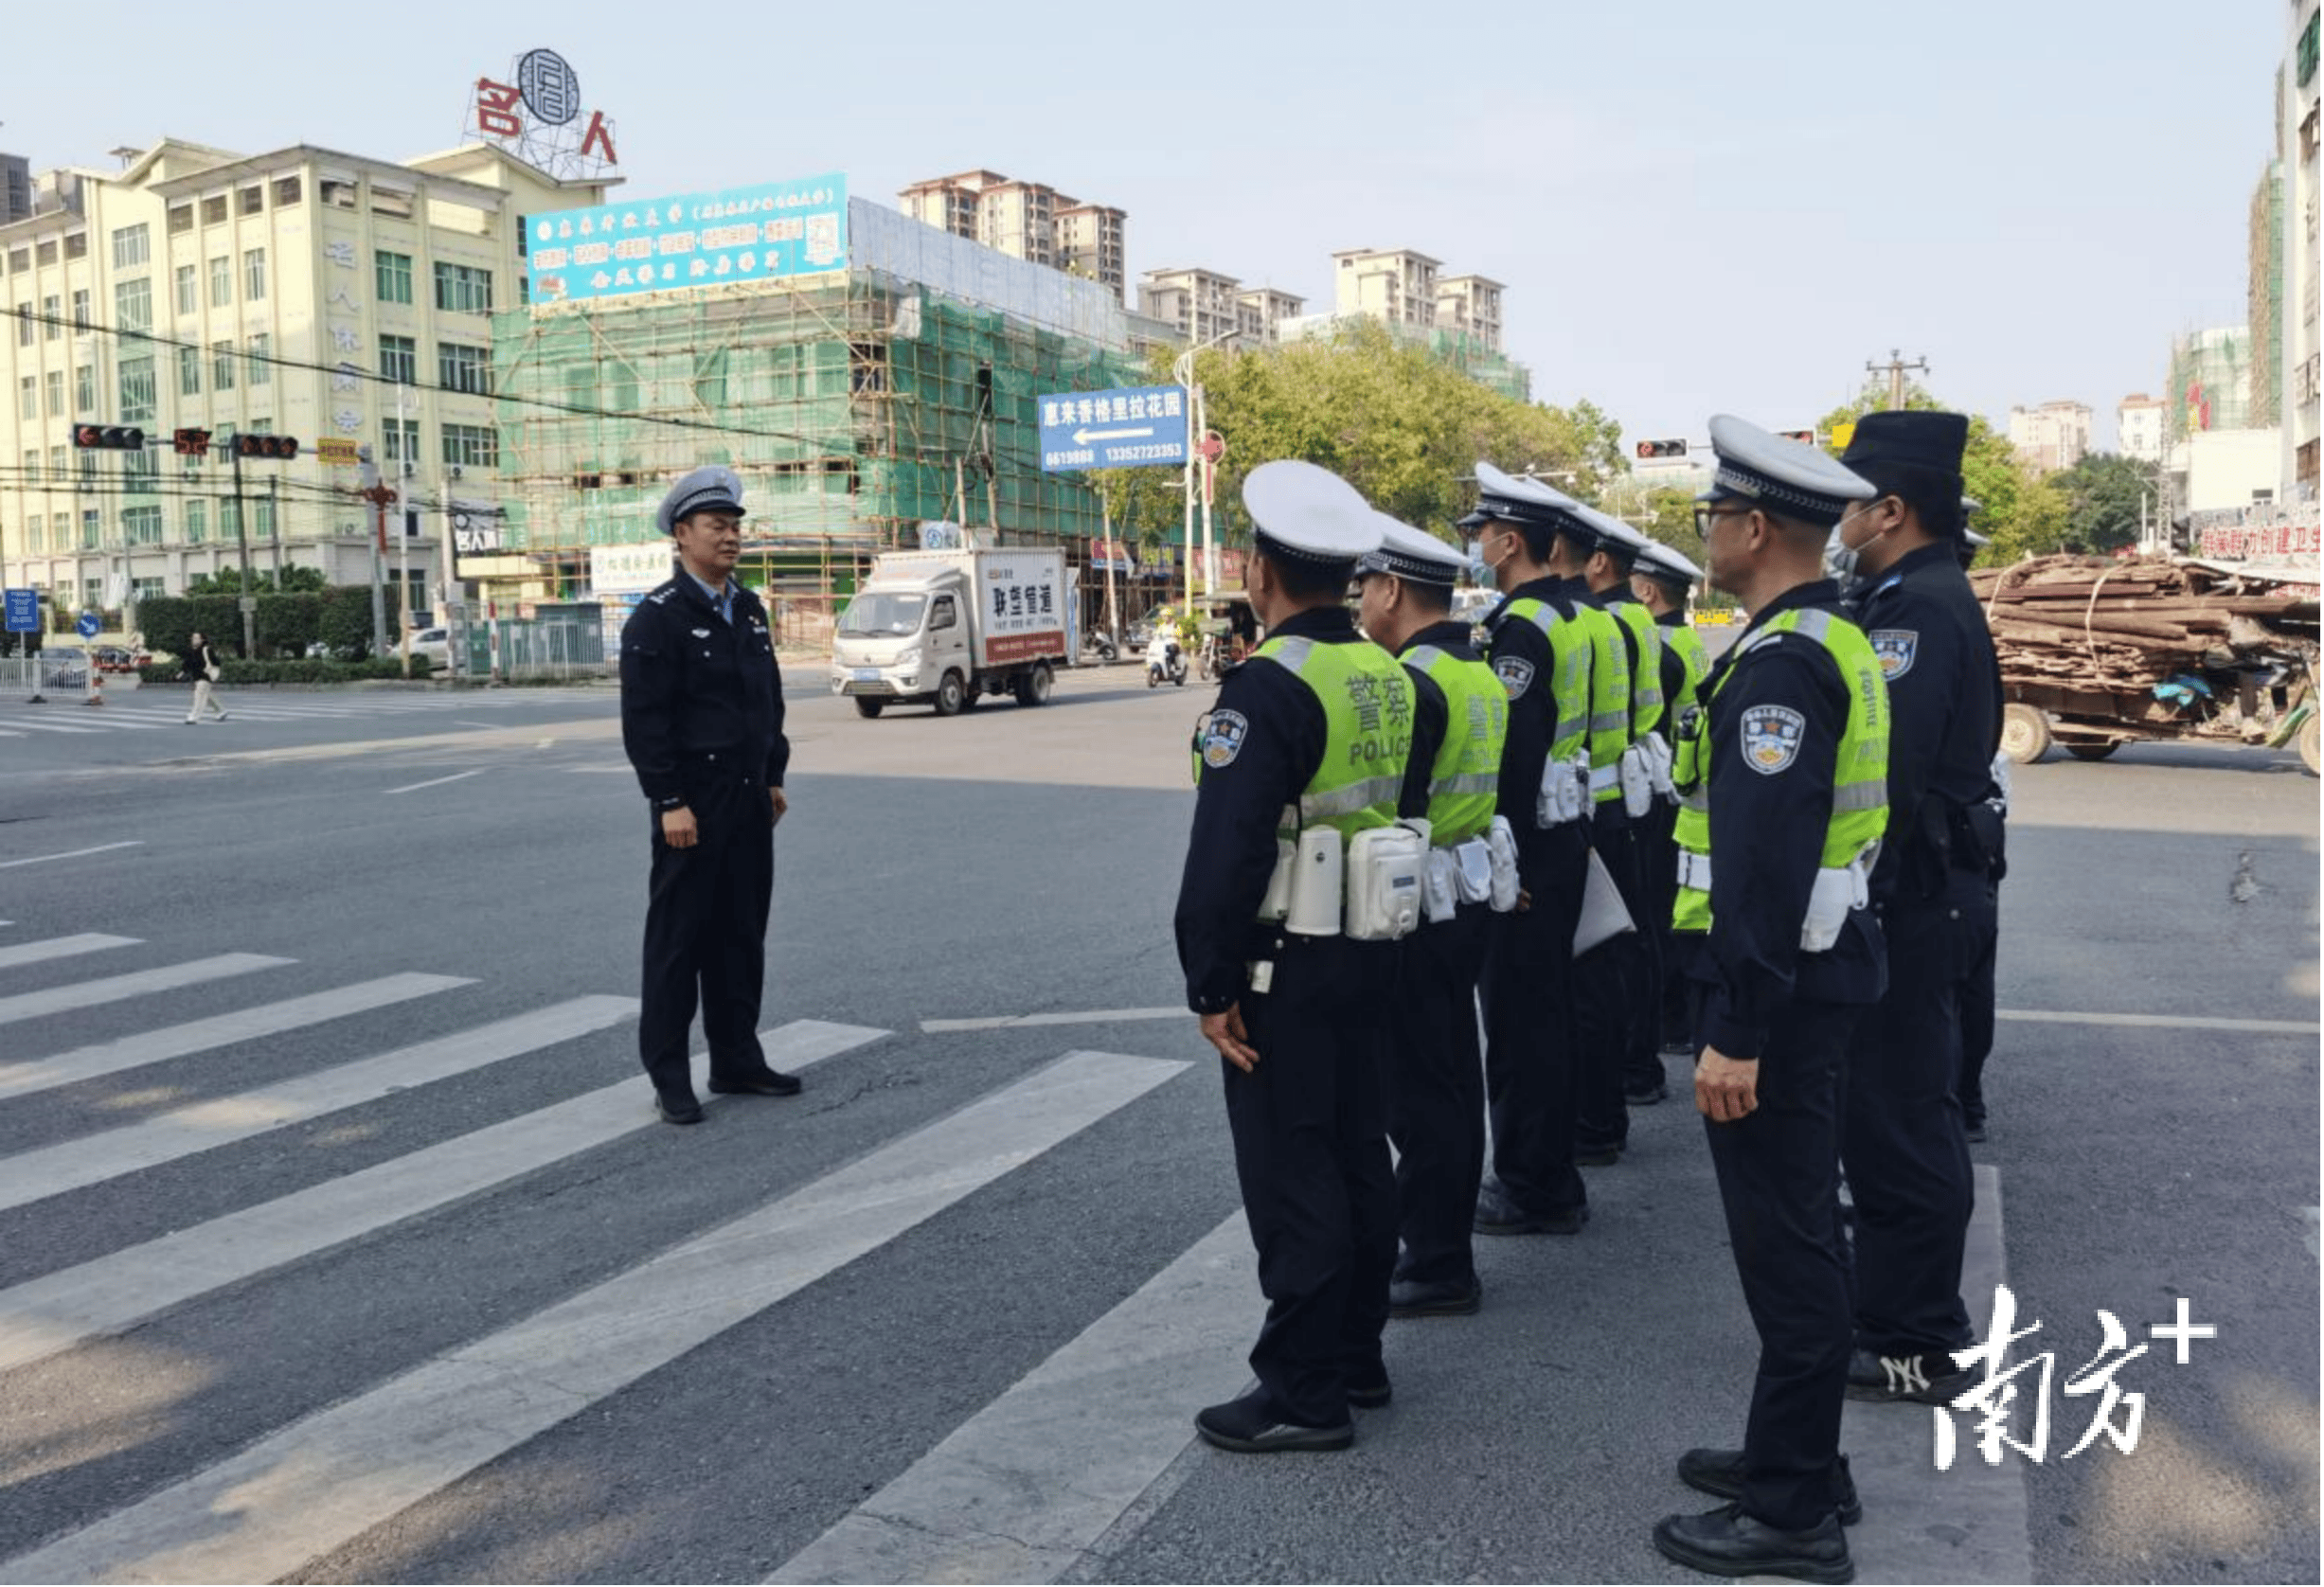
[{"left": 0, "top": 0, "right": 2287, "bottom": 453}]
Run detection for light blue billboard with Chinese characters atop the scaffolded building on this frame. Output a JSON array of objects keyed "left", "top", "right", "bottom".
[{"left": 526, "top": 172, "right": 849, "bottom": 304}]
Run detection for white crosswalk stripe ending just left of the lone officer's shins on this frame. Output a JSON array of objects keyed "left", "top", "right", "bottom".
[{"left": 0, "top": 997, "right": 636, "bottom": 1210}]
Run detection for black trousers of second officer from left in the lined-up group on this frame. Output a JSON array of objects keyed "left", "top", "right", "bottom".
[{"left": 1387, "top": 904, "right": 1494, "bottom": 1285}]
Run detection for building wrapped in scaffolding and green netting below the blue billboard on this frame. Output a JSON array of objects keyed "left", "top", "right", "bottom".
[{"left": 492, "top": 200, "right": 1171, "bottom": 641}]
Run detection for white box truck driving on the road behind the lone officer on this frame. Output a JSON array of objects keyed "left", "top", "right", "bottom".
[{"left": 832, "top": 546, "right": 1076, "bottom": 716}]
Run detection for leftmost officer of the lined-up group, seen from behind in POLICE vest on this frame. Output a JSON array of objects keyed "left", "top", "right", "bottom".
[{"left": 1176, "top": 462, "right": 1413, "bottom": 1454}]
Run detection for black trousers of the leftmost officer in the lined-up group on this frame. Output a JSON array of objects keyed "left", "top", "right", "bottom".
[{"left": 1220, "top": 938, "right": 1397, "bottom": 1427}]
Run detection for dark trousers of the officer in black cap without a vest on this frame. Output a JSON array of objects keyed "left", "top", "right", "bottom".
[{"left": 1841, "top": 871, "right": 1985, "bottom": 1355}]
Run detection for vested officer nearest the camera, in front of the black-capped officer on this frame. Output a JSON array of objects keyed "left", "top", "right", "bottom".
[{"left": 1654, "top": 414, "right": 1887, "bottom": 1582}]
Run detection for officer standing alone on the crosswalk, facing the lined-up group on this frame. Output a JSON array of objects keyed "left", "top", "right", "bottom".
[{"left": 620, "top": 467, "right": 799, "bottom": 1125}]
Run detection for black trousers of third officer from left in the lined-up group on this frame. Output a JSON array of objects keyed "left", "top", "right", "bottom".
[{"left": 1478, "top": 820, "right": 1590, "bottom": 1213}]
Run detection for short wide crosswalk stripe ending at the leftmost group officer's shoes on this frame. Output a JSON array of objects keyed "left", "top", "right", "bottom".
[{"left": 769, "top": 1213, "right": 1264, "bottom": 1582}]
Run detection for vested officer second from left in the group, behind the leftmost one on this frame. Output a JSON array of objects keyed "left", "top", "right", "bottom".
[{"left": 1357, "top": 521, "right": 1509, "bottom": 1317}]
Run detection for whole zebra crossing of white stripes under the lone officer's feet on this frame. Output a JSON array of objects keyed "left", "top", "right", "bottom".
[{"left": 0, "top": 927, "right": 1260, "bottom": 1582}]
